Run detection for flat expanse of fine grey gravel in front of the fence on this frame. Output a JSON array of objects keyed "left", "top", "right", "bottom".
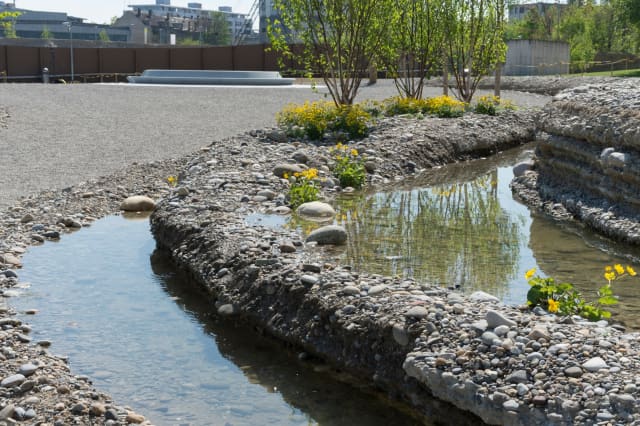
[{"left": 0, "top": 80, "right": 549, "bottom": 209}]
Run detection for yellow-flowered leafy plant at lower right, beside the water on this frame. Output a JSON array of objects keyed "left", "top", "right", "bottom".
[{"left": 525, "top": 264, "right": 636, "bottom": 321}]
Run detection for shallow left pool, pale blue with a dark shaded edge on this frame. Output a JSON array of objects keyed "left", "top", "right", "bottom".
[{"left": 12, "top": 217, "right": 429, "bottom": 425}]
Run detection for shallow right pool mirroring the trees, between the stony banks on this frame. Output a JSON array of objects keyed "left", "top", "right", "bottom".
[{"left": 248, "top": 146, "right": 640, "bottom": 329}]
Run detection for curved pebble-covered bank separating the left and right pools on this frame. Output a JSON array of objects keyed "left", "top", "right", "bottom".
[{"left": 151, "top": 114, "right": 640, "bottom": 425}]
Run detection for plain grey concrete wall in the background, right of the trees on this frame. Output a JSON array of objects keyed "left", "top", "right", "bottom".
[{"left": 503, "top": 40, "right": 570, "bottom": 75}]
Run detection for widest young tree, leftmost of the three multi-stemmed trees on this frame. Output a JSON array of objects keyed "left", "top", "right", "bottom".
[{"left": 269, "top": 0, "right": 392, "bottom": 105}]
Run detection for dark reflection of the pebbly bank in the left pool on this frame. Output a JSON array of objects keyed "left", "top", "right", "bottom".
[{"left": 151, "top": 251, "right": 436, "bottom": 425}]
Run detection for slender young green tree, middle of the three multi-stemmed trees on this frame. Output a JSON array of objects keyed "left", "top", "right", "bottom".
[{"left": 382, "top": 0, "right": 443, "bottom": 99}]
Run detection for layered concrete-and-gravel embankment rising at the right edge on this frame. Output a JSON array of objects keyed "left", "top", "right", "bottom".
[{"left": 512, "top": 80, "right": 640, "bottom": 244}]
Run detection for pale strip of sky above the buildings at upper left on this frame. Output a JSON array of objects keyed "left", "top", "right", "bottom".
[{"left": 11, "top": 0, "right": 253, "bottom": 24}]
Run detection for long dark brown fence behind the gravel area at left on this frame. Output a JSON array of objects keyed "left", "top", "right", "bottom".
[{"left": 0, "top": 45, "right": 300, "bottom": 81}]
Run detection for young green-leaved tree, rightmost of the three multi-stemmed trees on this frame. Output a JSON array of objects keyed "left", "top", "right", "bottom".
[{"left": 443, "top": 0, "right": 507, "bottom": 102}]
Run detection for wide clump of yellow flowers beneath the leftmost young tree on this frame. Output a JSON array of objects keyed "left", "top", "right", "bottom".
[{"left": 276, "top": 102, "right": 371, "bottom": 140}]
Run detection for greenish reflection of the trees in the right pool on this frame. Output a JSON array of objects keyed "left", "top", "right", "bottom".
[{"left": 338, "top": 168, "right": 522, "bottom": 297}]
